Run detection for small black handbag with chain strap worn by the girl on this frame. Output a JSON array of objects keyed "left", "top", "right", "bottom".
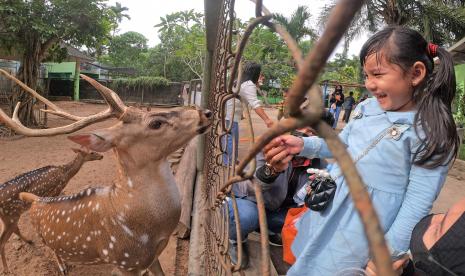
[{"left": 303, "top": 125, "right": 401, "bottom": 212}]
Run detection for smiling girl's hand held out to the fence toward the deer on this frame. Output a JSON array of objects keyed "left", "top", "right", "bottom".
[{"left": 263, "top": 135, "right": 304, "bottom": 172}]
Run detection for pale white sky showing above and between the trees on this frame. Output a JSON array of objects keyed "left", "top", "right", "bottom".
[{"left": 108, "top": 0, "right": 367, "bottom": 56}]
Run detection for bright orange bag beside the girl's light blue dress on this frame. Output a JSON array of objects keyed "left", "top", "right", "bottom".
[{"left": 281, "top": 205, "right": 308, "bottom": 264}]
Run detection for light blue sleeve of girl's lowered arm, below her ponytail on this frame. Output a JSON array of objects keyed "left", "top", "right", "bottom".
[{"left": 380, "top": 165, "right": 449, "bottom": 257}]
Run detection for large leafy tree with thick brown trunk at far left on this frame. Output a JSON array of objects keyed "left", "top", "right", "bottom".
[{"left": 0, "top": 0, "right": 117, "bottom": 125}]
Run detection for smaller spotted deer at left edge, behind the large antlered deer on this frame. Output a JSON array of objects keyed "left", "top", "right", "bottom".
[{"left": 0, "top": 149, "right": 103, "bottom": 273}]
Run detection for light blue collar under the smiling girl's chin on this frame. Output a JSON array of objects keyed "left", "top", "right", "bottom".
[{"left": 361, "top": 98, "right": 417, "bottom": 125}]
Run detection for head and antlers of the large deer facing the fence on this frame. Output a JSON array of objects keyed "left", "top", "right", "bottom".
[{"left": 0, "top": 69, "right": 211, "bottom": 147}]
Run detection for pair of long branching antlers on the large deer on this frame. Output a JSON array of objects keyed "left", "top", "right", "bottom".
[{"left": 0, "top": 69, "right": 127, "bottom": 136}]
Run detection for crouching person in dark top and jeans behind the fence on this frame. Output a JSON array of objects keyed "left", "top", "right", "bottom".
[{"left": 228, "top": 111, "right": 334, "bottom": 268}]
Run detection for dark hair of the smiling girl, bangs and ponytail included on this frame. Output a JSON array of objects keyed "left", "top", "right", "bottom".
[{"left": 360, "top": 26, "right": 459, "bottom": 168}]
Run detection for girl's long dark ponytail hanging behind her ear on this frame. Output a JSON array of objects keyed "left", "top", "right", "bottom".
[{"left": 413, "top": 45, "right": 460, "bottom": 168}]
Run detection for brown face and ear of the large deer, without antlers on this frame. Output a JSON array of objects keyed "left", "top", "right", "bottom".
[{"left": 68, "top": 107, "right": 210, "bottom": 165}]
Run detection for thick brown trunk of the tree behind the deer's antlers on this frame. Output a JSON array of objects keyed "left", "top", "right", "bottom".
[{"left": 10, "top": 34, "right": 42, "bottom": 126}]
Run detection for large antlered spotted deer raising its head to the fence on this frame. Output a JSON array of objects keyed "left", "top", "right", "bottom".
[{"left": 0, "top": 70, "right": 211, "bottom": 275}]
